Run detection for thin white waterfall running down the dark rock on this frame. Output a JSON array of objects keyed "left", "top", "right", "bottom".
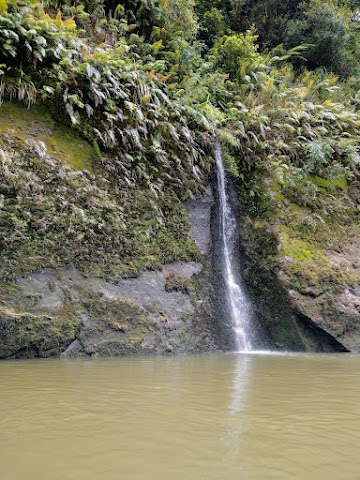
[{"left": 214, "top": 145, "right": 252, "bottom": 352}]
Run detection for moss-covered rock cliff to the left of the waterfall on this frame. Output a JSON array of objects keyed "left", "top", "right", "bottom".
[{"left": 0, "top": 104, "right": 219, "bottom": 358}]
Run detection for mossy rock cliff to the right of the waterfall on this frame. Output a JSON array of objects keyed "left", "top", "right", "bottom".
[{"left": 240, "top": 169, "right": 360, "bottom": 352}]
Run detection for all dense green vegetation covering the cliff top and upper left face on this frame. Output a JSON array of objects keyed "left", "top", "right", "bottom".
[{"left": 0, "top": 0, "right": 360, "bottom": 278}]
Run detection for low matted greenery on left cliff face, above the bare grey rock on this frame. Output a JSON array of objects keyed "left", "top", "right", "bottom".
[{"left": 0, "top": 133, "right": 197, "bottom": 279}]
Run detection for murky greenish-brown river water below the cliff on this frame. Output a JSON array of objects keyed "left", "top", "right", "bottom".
[{"left": 0, "top": 355, "right": 360, "bottom": 480}]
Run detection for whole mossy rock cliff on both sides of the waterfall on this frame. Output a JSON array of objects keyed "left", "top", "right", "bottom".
[{"left": 0, "top": 104, "right": 360, "bottom": 358}]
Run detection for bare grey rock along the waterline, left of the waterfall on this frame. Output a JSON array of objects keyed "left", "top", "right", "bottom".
[{"left": 0, "top": 188, "right": 219, "bottom": 358}]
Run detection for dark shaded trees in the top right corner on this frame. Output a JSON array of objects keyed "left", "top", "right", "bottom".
[{"left": 197, "top": 0, "right": 360, "bottom": 76}]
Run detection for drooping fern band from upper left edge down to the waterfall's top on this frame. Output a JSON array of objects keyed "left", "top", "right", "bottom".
[{"left": 0, "top": 4, "right": 214, "bottom": 196}]
